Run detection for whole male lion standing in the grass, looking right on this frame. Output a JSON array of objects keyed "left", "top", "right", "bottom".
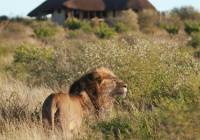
[{"left": 42, "top": 67, "right": 127, "bottom": 137}]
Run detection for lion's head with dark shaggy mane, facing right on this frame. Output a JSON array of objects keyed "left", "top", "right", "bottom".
[{"left": 69, "top": 67, "right": 127, "bottom": 114}]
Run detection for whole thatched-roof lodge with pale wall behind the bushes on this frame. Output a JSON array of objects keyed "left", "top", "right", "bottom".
[{"left": 28, "top": 0, "right": 155, "bottom": 24}]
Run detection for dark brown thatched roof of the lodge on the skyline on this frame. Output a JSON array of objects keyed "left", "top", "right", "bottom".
[{"left": 28, "top": 0, "right": 155, "bottom": 17}]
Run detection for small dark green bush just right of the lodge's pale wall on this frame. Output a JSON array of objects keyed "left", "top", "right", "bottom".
[{"left": 64, "top": 18, "right": 82, "bottom": 30}]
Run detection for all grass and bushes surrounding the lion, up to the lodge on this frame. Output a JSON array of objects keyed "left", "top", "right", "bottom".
[{"left": 0, "top": 7, "right": 200, "bottom": 140}]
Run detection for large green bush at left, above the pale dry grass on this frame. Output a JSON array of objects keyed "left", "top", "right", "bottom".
[{"left": 11, "top": 44, "right": 53, "bottom": 85}]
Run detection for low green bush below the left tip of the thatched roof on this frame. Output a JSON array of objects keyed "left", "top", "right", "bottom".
[{"left": 33, "top": 21, "right": 58, "bottom": 38}]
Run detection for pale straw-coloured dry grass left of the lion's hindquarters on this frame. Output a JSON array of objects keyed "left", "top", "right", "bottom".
[{"left": 0, "top": 75, "right": 52, "bottom": 140}]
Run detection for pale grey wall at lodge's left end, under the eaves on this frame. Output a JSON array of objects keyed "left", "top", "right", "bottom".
[{"left": 52, "top": 10, "right": 66, "bottom": 25}]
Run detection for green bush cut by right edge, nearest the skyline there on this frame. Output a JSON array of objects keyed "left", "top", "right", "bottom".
[{"left": 185, "top": 21, "right": 200, "bottom": 34}]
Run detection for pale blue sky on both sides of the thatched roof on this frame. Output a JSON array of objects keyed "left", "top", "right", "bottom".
[{"left": 0, "top": 0, "right": 200, "bottom": 17}]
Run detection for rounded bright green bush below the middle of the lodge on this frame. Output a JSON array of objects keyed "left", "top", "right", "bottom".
[{"left": 95, "top": 23, "right": 114, "bottom": 38}]
